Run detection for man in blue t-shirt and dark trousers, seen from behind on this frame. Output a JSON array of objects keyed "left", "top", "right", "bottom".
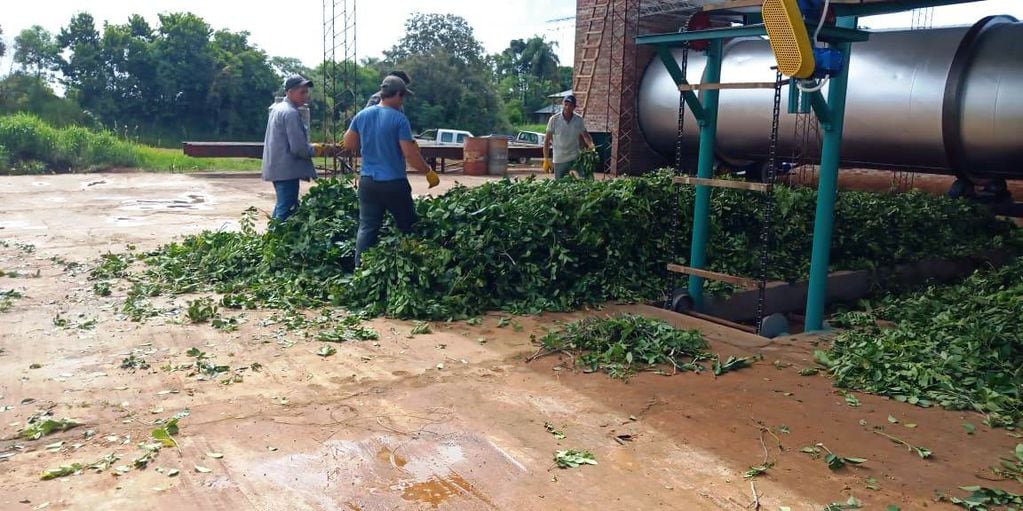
[{"left": 345, "top": 76, "right": 439, "bottom": 266}]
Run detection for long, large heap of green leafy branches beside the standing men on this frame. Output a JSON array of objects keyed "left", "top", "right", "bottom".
[{"left": 107, "top": 172, "right": 1023, "bottom": 320}]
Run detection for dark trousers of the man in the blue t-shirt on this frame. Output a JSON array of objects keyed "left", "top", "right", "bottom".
[{"left": 355, "top": 176, "right": 416, "bottom": 267}]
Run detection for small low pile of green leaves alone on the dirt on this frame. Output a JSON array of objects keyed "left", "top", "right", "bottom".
[{"left": 540, "top": 314, "right": 710, "bottom": 378}]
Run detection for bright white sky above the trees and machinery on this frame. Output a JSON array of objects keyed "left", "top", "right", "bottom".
[{"left": 0, "top": 0, "right": 1023, "bottom": 74}]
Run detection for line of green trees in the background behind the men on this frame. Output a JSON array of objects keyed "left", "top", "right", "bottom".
[{"left": 0, "top": 12, "right": 571, "bottom": 145}]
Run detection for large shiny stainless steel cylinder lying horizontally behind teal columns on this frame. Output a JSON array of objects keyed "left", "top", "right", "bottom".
[{"left": 638, "top": 16, "right": 1023, "bottom": 179}]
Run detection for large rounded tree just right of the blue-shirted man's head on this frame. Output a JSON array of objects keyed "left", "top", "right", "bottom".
[{"left": 384, "top": 13, "right": 508, "bottom": 134}]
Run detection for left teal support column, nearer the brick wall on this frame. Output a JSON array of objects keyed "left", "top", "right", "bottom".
[{"left": 688, "top": 39, "right": 723, "bottom": 309}]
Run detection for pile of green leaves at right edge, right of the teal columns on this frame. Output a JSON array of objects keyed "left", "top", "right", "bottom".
[{"left": 817, "top": 258, "right": 1023, "bottom": 426}]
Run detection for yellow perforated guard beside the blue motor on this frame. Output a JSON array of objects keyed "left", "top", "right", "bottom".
[{"left": 761, "top": 0, "right": 815, "bottom": 78}]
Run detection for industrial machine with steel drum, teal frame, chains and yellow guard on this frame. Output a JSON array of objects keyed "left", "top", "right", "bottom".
[{"left": 636, "top": 0, "right": 1023, "bottom": 336}]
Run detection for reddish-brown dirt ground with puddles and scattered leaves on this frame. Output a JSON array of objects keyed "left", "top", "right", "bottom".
[{"left": 0, "top": 174, "right": 1020, "bottom": 511}]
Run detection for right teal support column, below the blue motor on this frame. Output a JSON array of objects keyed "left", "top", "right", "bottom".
[{"left": 805, "top": 17, "right": 856, "bottom": 332}]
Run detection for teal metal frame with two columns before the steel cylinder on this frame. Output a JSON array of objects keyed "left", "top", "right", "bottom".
[{"left": 636, "top": 14, "right": 871, "bottom": 331}]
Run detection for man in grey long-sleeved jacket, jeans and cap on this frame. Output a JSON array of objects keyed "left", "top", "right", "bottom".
[{"left": 263, "top": 75, "right": 336, "bottom": 222}]
